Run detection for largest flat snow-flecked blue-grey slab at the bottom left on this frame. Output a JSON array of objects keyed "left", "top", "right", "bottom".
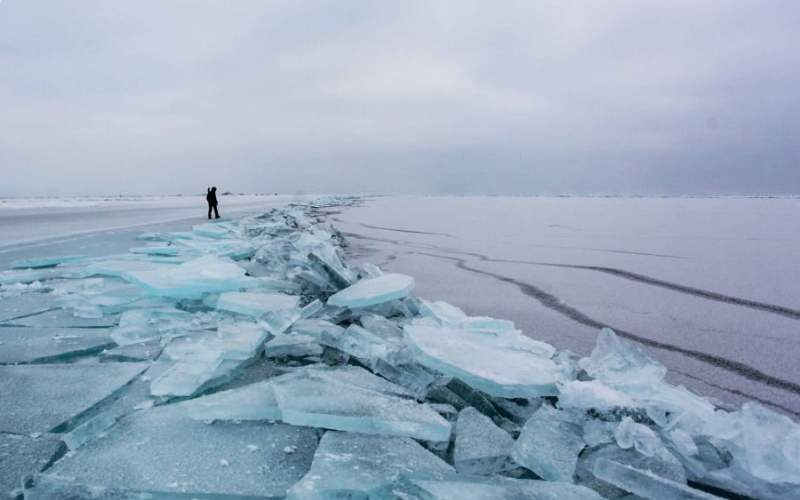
[{"left": 47, "top": 405, "right": 317, "bottom": 496}]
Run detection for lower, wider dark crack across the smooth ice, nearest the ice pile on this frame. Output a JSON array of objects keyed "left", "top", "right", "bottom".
[{"left": 417, "top": 252, "right": 800, "bottom": 394}]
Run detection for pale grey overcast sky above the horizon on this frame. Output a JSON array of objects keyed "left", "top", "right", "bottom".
[{"left": 0, "top": 0, "right": 800, "bottom": 196}]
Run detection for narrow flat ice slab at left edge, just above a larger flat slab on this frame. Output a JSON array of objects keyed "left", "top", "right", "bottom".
[{"left": 0, "top": 326, "right": 115, "bottom": 363}]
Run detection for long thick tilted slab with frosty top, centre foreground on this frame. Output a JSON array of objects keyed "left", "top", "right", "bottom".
[{"left": 272, "top": 367, "right": 450, "bottom": 441}]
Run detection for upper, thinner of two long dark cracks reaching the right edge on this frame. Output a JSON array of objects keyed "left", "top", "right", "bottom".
[{"left": 345, "top": 233, "right": 800, "bottom": 319}]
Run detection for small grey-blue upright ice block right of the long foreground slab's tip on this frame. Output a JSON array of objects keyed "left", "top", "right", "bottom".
[{"left": 453, "top": 406, "right": 514, "bottom": 475}]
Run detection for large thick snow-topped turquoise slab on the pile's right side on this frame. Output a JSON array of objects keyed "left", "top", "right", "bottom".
[{"left": 404, "top": 325, "right": 560, "bottom": 398}]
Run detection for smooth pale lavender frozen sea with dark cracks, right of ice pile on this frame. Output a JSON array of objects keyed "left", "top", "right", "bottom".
[{"left": 330, "top": 197, "right": 800, "bottom": 418}]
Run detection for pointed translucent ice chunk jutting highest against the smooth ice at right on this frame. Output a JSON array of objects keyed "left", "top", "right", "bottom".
[{"left": 581, "top": 328, "right": 667, "bottom": 386}]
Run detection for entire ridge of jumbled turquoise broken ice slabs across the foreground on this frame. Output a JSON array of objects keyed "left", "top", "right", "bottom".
[{"left": 0, "top": 198, "right": 800, "bottom": 499}]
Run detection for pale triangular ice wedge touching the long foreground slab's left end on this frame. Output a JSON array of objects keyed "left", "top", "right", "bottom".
[{"left": 179, "top": 381, "right": 281, "bottom": 421}]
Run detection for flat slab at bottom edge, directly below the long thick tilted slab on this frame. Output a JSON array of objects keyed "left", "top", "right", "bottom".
[{"left": 287, "top": 432, "right": 453, "bottom": 500}]
